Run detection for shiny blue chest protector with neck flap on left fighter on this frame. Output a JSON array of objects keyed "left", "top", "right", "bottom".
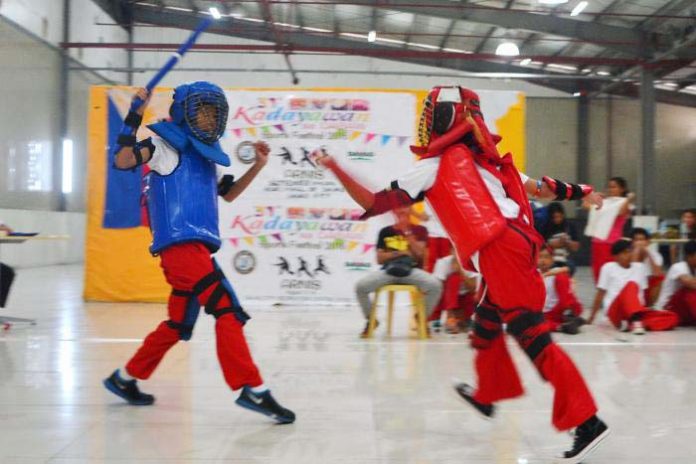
[{"left": 147, "top": 122, "right": 229, "bottom": 255}]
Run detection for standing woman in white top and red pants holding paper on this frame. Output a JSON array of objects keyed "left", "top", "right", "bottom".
[{"left": 588, "top": 177, "right": 634, "bottom": 282}]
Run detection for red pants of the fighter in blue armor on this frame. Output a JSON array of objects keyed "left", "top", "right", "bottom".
[{"left": 126, "top": 242, "right": 263, "bottom": 390}]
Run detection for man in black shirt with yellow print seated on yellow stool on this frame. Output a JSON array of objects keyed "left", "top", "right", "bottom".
[{"left": 355, "top": 206, "right": 442, "bottom": 336}]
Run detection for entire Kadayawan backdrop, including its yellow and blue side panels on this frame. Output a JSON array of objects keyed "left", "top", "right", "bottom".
[{"left": 85, "top": 87, "right": 524, "bottom": 305}]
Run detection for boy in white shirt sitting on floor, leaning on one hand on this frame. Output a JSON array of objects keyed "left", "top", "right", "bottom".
[{"left": 588, "top": 239, "right": 677, "bottom": 335}]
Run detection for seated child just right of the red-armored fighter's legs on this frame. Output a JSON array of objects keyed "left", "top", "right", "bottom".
[{"left": 538, "top": 247, "right": 585, "bottom": 335}]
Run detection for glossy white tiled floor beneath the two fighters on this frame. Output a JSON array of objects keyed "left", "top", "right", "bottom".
[{"left": 0, "top": 266, "right": 696, "bottom": 464}]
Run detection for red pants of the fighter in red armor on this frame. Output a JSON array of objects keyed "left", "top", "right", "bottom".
[{"left": 474, "top": 221, "right": 597, "bottom": 430}]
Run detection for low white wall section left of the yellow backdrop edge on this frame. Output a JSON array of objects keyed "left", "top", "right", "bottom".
[{"left": 0, "top": 209, "right": 85, "bottom": 267}]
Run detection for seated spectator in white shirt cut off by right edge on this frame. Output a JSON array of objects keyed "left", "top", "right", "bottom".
[{"left": 655, "top": 240, "right": 696, "bottom": 325}]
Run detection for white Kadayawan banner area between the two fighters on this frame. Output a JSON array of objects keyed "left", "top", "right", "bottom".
[{"left": 216, "top": 91, "right": 416, "bottom": 304}]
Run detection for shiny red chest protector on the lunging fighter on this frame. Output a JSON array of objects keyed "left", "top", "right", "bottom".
[{"left": 425, "top": 144, "right": 507, "bottom": 262}]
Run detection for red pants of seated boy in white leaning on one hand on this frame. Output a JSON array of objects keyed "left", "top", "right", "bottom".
[{"left": 607, "top": 282, "right": 678, "bottom": 331}]
